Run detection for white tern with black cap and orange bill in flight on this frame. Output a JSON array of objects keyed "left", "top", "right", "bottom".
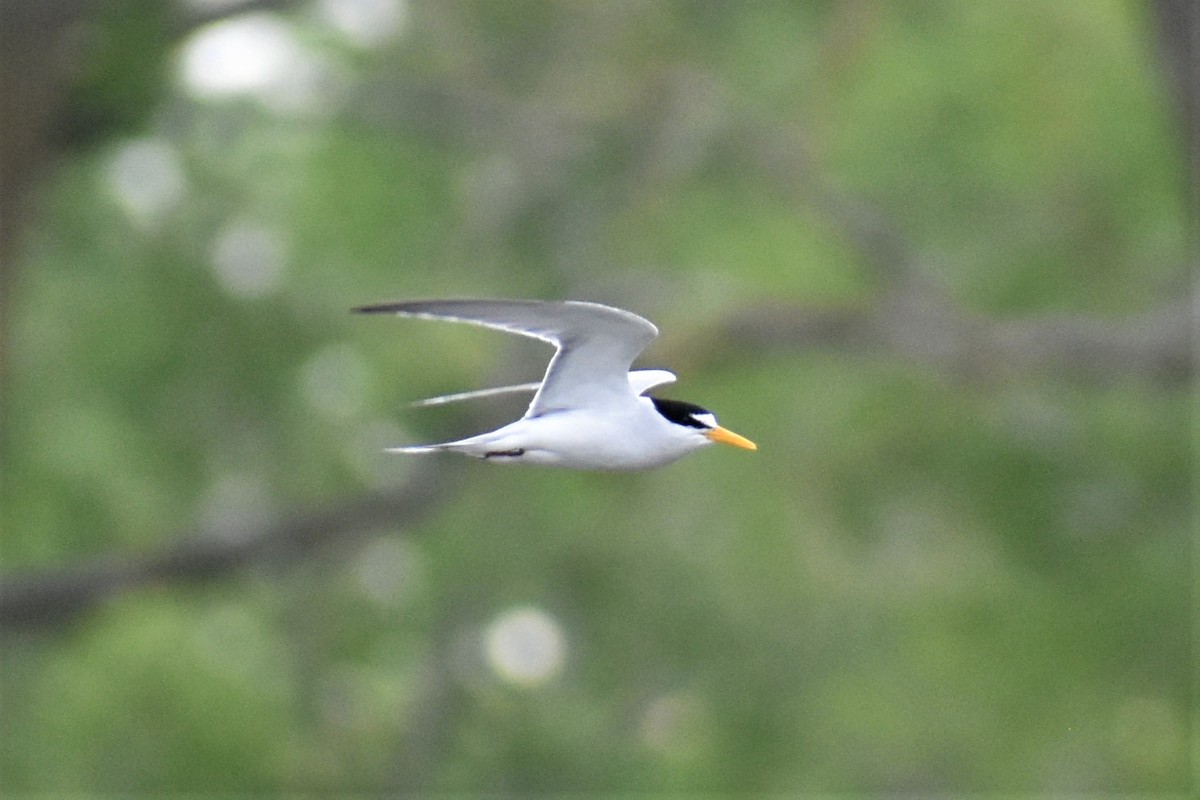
[{"left": 354, "top": 300, "right": 757, "bottom": 470}]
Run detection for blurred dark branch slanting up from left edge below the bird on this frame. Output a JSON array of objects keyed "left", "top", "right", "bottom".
[{"left": 0, "top": 461, "right": 452, "bottom": 631}]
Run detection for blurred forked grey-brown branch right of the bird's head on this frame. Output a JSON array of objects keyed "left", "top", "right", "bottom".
[{"left": 713, "top": 107, "right": 1200, "bottom": 385}]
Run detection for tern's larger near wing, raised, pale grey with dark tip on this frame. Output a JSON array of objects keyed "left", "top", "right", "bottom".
[{"left": 355, "top": 300, "right": 662, "bottom": 417}]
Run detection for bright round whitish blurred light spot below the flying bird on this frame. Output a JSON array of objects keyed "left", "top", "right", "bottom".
[{"left": 485, "top": 607, "right": 566, "bottom": 686}]
